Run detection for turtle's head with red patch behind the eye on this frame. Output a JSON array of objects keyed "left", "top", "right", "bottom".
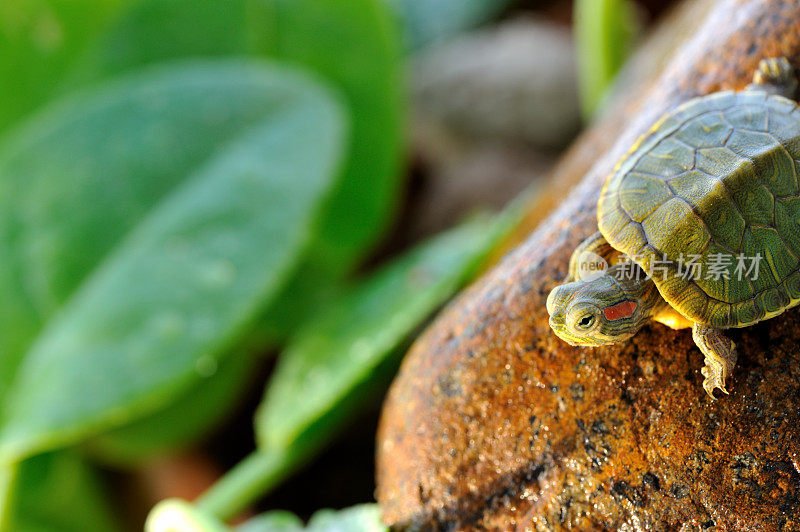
[{"left": 547, "top": 274, "right": 652, "bottom": 346}]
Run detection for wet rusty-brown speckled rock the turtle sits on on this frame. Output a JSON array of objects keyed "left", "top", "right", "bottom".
[{"left": 377, "top": 0, "right": 800, "bottom": 530}]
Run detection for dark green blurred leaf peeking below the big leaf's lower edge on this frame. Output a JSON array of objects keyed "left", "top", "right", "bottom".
[{"left": 88, "top": 350, "right": 258, "bottom": 466}]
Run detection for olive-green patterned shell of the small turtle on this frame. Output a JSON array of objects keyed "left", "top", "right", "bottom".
[{"left": 597, "top": 91, "right": 800, "bottom": 328}]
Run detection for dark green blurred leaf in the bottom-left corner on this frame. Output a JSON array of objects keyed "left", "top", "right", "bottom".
[{"left": 3, "top": 452, "right": 120, "bottom": 532}]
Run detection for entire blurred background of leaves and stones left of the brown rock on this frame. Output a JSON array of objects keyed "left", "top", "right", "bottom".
[{"left": 0, "top": 0, "right": 672, "bottom": 532}]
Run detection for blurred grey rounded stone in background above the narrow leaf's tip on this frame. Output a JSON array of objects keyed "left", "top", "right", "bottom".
[{"left": 413, "top": 18, "right": 580, "bottom": 148}]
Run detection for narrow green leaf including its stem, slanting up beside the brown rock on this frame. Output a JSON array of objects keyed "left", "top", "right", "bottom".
[{"left": 198, "top": 216, "right": 508, "bottom": 518}]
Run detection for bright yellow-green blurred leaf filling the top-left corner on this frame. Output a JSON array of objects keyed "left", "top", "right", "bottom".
[{"left": 0, "top": 0, "right": 128, "bottom": 130}]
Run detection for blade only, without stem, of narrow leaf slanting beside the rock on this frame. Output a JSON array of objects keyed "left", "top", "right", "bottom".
[{"left": 256, "top": 218, "right": 496, "bottom": 449}]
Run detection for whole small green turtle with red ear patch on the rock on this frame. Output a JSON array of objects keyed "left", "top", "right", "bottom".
[{"left": 547, "top": 57, "right": 800, "bottom": 399}]
